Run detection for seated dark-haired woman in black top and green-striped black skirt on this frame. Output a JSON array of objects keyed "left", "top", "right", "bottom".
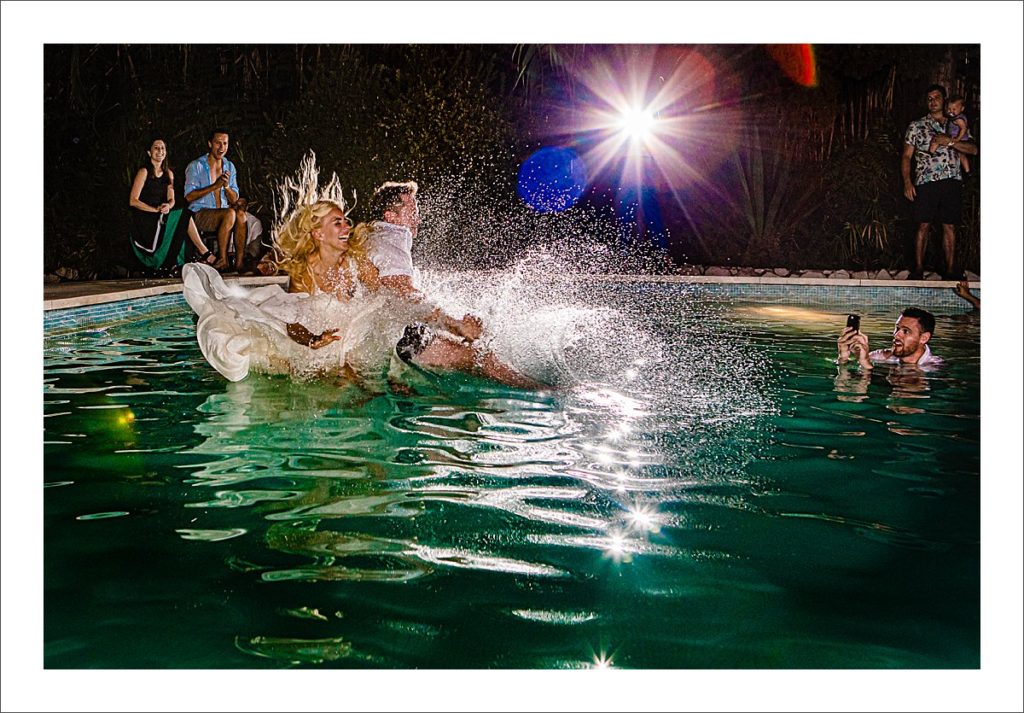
[{"left": 128, "top": 138, "right": 217, "bottom": 270}]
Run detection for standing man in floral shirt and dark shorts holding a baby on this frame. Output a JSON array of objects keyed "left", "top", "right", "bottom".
[{"left": 900, "top": 84, "right": 978, "bottom": 280}]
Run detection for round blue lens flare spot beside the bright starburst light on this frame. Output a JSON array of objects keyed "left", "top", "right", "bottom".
[{"left": 518, "top": 146, "right": 587, "bottom": 213}]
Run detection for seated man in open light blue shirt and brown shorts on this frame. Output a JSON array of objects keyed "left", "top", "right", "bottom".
[{"left": 185, "top": 129, "right": 247, "bottom": 270}]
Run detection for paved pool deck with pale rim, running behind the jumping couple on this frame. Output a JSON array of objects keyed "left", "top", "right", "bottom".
[{"left": 43, "top": 275, "right": 981, "bottom": 311}]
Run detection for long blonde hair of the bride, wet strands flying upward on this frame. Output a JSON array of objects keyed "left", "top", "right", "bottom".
[{"left": 273, "top": 151, "right": 366, "bottom": 292}]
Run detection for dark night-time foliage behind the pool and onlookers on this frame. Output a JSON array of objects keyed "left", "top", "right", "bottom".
[{"left": 44, "top": 45, "right": 981, "bottom": 278}]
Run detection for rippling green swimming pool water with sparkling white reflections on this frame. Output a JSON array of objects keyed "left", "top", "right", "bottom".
[{"left": 44, "top": 280, "right": 980, "bottom": 669}]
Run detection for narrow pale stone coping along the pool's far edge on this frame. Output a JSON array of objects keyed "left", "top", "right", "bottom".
[{"left": 43, "top": 274, "right": 981, "bottom": 311}]
